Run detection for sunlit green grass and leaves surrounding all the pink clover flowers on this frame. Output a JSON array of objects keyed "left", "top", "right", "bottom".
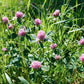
[{"left": 0, "top": 0, "right": 84, "bottom": 84}]
